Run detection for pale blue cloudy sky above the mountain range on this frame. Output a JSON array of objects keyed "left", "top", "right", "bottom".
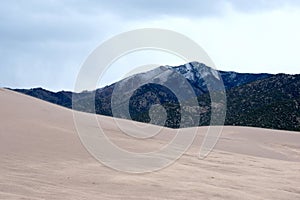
[{"left": 0, "top": 0, "right": 300, "bottom": 91}]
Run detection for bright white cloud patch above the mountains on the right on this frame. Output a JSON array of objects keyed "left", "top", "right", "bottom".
[{"left": 135, "top": 7, "right": 300, "bottom": 74}]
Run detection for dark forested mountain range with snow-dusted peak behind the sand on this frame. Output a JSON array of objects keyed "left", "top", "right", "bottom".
[{"left": 10, "top": 62, "right": 300, "bottom": 131}]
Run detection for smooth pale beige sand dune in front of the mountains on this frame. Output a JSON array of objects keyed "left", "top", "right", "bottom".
[{"left": 0, "top": 89, "right": 300, "bottom": 200}]
